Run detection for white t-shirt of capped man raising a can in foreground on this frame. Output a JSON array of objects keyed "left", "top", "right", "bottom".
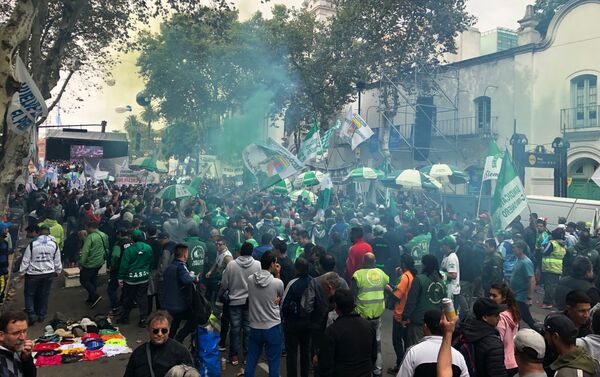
[{"left": 397, "top": 335, "right": 469, "bottom": 377}]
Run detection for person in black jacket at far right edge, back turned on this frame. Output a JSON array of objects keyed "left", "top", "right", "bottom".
[{"left": 554, "top": 256, "right": 600, "bottom": 311}]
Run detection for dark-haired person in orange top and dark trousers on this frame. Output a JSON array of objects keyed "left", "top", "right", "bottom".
[{"left": 388, "top": 254, "right": 417, "bottom": 375}]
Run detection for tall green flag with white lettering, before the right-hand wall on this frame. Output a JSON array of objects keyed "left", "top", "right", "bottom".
[{"left": 492, "top": 151, "right": 527, "bottom": 230}]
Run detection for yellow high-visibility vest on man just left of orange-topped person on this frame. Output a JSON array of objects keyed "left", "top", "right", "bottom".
[{"left": 352, "top": 268, "right": 390, "bottom": 319}]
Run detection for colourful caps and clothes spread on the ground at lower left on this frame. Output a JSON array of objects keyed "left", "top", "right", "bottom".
[{"left": 33, "top": 313, "right": 131, "bottom": 367}]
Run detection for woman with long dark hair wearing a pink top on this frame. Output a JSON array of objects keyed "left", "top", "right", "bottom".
[{"left": 489, "top": 283, "right": 521, "bottom": 377}]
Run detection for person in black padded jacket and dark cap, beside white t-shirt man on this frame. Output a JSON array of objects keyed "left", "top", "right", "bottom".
[{"left": 462, "top": 297, "right": 507, "bottom": 377}]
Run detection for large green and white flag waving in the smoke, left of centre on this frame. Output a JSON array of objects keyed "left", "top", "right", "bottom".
[{"left": 242, "top": 138, "right": 304, "bottom": 190}]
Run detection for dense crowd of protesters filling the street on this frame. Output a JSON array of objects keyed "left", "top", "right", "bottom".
[{"left": 0, "top": 168, "right": 600, "bottom": 377}]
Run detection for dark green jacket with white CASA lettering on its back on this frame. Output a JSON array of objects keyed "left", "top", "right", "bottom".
[{"left": 119, "top": 242, "right": 153, "bottom": 284}]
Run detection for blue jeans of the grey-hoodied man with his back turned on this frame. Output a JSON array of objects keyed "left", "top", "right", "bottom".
[{"left": 245, "top": 325, "right": 283, "bottom": 377}]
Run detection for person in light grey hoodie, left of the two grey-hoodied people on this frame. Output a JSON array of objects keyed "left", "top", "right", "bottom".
[{"left": 218, "top": 242, "right": 260, "bottom": 365}]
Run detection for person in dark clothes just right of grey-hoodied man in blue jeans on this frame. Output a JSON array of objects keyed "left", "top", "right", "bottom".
[{"left": 281, "top": 257, "right": 313, "bottom": 377}]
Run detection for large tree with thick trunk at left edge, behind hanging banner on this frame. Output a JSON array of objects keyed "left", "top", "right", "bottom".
[{"left": 0, "top": 0, "right": 228, "bottom": 203}]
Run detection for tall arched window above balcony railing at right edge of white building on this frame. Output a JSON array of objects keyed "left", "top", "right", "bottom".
[{"left": 571, "top": 75, "right": 598, "bottom": 128}]
